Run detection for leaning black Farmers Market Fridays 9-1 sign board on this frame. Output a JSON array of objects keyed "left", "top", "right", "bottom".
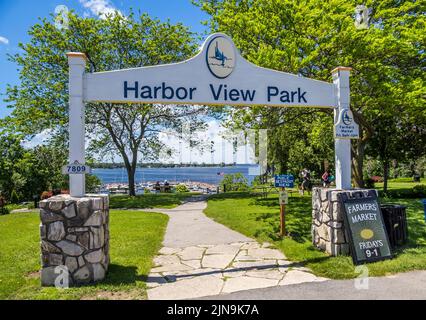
[{"left": 340, "top": 194, "right": 392, "bottom": 265}]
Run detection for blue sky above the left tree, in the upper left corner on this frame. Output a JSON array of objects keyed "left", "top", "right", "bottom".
[{"left": 0, "top": 0, "right": 208, "bottom": 118}]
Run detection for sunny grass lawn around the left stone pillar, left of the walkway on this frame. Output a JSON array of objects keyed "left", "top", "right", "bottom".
[{"left": 0, "top": 210, "right": 168, "bottom": 299}]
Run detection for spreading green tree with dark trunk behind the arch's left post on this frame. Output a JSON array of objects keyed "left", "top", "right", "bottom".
[{"left": 7, "top": 13, "right": 207, "bottom": 195}]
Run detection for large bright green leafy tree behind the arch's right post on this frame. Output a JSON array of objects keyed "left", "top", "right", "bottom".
[{"left": 194, "top": 0, "right": 426, "bottom": 187}]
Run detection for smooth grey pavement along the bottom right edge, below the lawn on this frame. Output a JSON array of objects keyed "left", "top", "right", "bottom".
[{"left": 198, "top": 271, "right": 426, "bottom": 300}]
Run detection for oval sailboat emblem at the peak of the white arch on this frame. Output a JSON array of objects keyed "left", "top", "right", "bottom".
[{"left": 206, "top": 36, "right": 235, "bottom": 79}]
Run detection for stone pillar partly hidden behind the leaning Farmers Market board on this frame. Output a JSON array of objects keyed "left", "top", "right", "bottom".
[{"left": 312, "top": 188, "right": 377, "bottom": 256}]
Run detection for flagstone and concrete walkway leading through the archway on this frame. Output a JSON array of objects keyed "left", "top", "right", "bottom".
[{"left": 144, "top": 201, "right": 326, "bottom": 300}]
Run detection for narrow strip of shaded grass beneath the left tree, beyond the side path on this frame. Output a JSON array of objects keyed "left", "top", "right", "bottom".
[{"left": 109, "top": 193, "right": 194, "bottom": 209}]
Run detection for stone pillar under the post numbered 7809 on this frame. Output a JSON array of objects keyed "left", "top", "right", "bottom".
[{"left": 40, "top": 195, "right": 109, "bottom": 286}]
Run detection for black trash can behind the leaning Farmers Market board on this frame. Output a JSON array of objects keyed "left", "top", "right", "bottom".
[{"left": 380, "top": 204, "right": 408, "bottom": 248}]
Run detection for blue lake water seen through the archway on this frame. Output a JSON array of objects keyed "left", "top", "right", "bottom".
[{"left": 92, "top": 165, "right": 254, "bottom": 185}]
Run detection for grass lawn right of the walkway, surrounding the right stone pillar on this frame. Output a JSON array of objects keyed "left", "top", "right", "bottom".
[{"left": 205, "top": 185, "right": 426, "bottom": 279}]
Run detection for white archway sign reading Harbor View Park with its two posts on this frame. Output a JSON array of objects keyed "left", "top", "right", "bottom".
[{"left": 68, "top": 33, "right": 358, "bottom": 197}]
